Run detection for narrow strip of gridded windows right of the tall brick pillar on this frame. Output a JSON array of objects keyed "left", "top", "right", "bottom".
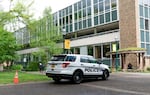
[{"left": 139, "top": 0, "right": 150, "bottom": 55}]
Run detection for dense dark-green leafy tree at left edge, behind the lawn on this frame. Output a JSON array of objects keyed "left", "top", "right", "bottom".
[{"left": 0, "top": 27, "right": 17, "bottom": 70}]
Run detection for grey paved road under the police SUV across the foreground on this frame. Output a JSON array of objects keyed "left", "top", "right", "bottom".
[{"left": 0, "top": 73, "right": 150, "bottom": 95}]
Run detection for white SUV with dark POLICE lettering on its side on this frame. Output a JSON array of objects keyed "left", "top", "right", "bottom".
[{"left": 46, "top": 54, "right": 110, "bottom": 83}]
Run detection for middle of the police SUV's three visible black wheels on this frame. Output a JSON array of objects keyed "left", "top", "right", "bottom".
[{"left": 72, "top": 71, "right": 83, "bottom": 84}]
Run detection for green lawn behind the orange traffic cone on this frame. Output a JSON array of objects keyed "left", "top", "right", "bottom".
[{"left": 0, "top": 71, "right": 50, "bottom": 84}]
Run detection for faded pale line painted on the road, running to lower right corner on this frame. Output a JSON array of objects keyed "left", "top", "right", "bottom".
[{"left": 81, "top": 84, "right": 150, "bottom": 95}]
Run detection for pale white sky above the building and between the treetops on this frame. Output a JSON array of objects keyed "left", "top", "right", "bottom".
[{"left": 0, "top": 0, "right": 79, "bottom": 18}]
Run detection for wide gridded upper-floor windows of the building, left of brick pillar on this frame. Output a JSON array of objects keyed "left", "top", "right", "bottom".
[{"left": 54, "top": 0, "right": 118, "bottom": 33}]
